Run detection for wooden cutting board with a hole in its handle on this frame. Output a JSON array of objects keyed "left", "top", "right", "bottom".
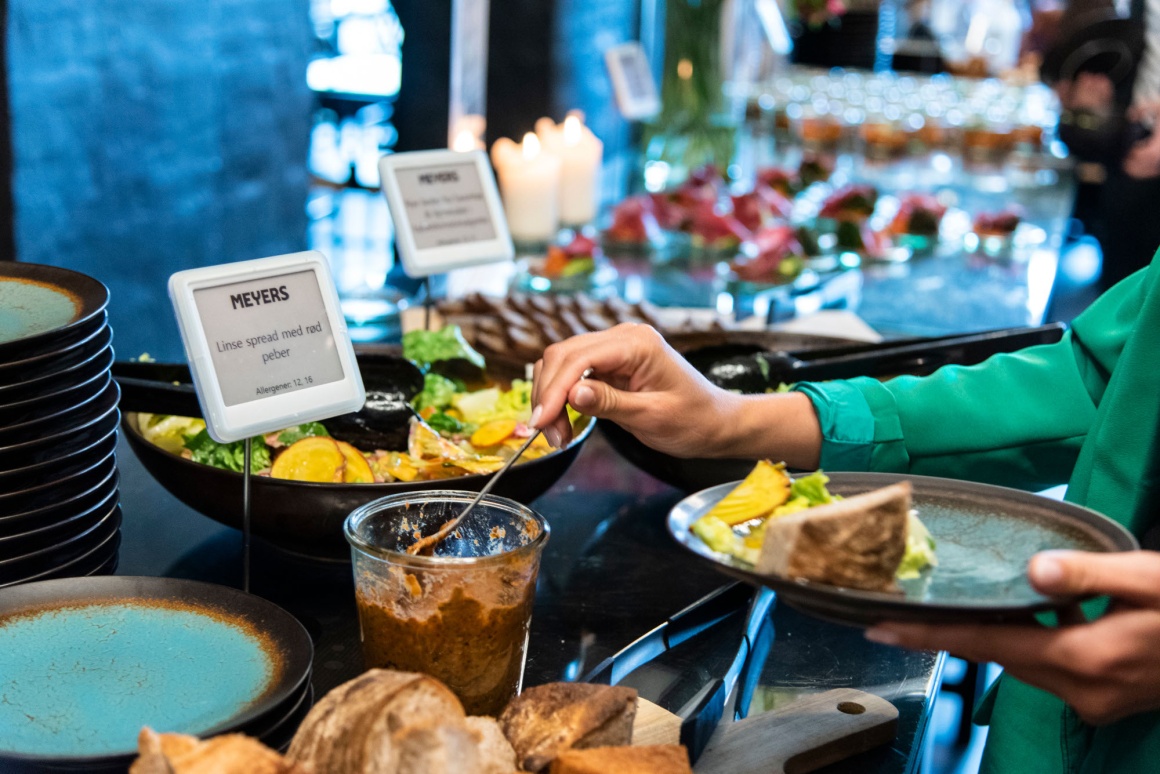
[{"left": 632, "top": 688, "right": 898, "bottom": 774}]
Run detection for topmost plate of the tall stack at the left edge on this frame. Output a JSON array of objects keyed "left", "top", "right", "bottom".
[{"left": 0, "top": 261, "right": 109, "bottom": 362}]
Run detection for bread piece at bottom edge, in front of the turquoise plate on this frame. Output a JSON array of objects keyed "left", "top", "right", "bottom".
[{"left": 129, "top": 728, "right": 309, "bottom": 774}]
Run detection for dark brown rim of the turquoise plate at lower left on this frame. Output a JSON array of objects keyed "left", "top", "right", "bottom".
[{"left": 0, "top": 576, "right": 314, "bottom": 766}]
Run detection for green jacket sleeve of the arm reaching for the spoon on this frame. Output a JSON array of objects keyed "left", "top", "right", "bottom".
[{"left": 796, "top": 272, "right": 1145, "bottom": 490}]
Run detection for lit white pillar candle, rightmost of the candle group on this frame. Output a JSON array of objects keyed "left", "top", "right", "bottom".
[{"left": 536, "top": 113, "right": 604, "bottom": 226}]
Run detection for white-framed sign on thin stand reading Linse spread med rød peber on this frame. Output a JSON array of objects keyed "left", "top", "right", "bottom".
[{"left": 169, "top": 252, "right": 367, "bottom": 592}]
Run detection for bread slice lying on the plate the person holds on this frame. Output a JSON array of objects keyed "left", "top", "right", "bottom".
[{"left": 756, "top": 482, "right": 911, "bottom": 591}]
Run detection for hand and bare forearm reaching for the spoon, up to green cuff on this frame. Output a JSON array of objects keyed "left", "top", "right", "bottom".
[{"left": 531, "top": 323, "right": 821, "bottom": 469}]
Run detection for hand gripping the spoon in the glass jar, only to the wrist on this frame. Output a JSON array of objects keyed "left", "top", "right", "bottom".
[{"left": 531, "top": 323, "right": 730, "bottom": 456}]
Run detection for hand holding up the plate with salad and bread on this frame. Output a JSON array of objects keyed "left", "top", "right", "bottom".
[{"left": 867, "top": 551, "right": 1160, "bottom": 725}]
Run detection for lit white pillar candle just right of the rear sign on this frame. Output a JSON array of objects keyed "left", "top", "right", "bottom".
[{"left": 492, "top": 132, "right": 560, "bottom": 243}]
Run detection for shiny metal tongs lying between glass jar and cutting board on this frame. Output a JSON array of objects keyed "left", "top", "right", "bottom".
[{"left": 582, "top": 583, "right": 776, "bottom": 762}]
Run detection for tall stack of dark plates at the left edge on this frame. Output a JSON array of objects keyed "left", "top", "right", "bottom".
[{"left": 0, "top": 262, "right": 121, "bottom": 587}]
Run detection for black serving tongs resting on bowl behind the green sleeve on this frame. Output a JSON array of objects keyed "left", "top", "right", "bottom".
[{"left": 686, "top": 323, "right": 1066, "bottom": 392}]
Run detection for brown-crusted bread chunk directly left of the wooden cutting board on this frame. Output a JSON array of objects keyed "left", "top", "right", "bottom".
[{"left": 499, "top": 682, "right": 637, "bottom": 772}]
